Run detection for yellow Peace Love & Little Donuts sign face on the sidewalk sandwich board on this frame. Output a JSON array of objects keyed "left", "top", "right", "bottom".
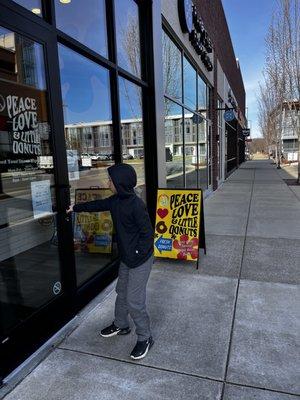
[{"left": 154, "top": 189, "right": 202, "bottom": 260}]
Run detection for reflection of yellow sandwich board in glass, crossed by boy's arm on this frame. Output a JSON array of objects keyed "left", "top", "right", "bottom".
[{"left": 74, "top": 189, "right": 113, "bottom": 253}]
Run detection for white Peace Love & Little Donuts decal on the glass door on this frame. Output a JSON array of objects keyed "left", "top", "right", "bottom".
[{"left": 0, "top": 81, "right": 51, "bottom": 172}]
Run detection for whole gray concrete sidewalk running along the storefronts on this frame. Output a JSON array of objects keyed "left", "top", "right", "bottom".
[{"left": 5, "top": 160, "right": 300, "bottom": 400}]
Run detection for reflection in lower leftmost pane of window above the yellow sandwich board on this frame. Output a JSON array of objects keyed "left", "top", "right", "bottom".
[{"left": 165, "top": 99, "right": 184, "bottom": 188}]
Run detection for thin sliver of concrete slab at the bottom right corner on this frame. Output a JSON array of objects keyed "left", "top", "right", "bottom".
[{"left": 223, "top": 385, "right": 298, "bottom": 400}]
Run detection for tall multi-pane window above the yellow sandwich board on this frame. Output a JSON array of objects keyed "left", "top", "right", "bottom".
[{"left": 163, "top": 32, "right": 209, "bottom": 189}]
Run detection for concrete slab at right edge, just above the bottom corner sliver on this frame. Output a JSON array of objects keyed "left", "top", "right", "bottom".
[{"left": 227, "top": 281, "right": 300, "bottom": 394}]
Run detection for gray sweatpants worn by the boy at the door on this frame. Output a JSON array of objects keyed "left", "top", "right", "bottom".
[{"left": 114, "top": 256, "right": 153, "bottom": 340}]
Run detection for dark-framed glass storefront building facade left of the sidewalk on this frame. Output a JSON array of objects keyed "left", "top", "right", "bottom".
[{"left": 0, "top": 0, "right": 246, "bottom": 381}]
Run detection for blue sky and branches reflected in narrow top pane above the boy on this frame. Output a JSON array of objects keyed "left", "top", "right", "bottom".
[{"left": 115, "top": 0, "right": 141, "bottom": 77}]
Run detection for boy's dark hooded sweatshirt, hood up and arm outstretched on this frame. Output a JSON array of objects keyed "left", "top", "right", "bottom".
[{"left": 73, "top": 164, "right": 153, "bottom": 268}]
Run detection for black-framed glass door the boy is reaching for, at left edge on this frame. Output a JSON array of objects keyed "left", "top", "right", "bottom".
[{"left": 0, "top": 14, "right": 72, "bottom": 377}]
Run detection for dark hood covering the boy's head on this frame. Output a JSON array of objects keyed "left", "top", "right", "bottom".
[{"left": 107, "top": 164, "right": 137, "bottom": 196}]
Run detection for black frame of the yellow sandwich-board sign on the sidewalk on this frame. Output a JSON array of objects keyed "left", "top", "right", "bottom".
[{"left": 154, "top": 188, "right": 206, "bottom": 269}]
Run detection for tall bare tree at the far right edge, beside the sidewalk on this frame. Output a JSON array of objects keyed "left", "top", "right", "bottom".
[{"left": 259, "top": 0, "right": 300, "bottom": 180}]
